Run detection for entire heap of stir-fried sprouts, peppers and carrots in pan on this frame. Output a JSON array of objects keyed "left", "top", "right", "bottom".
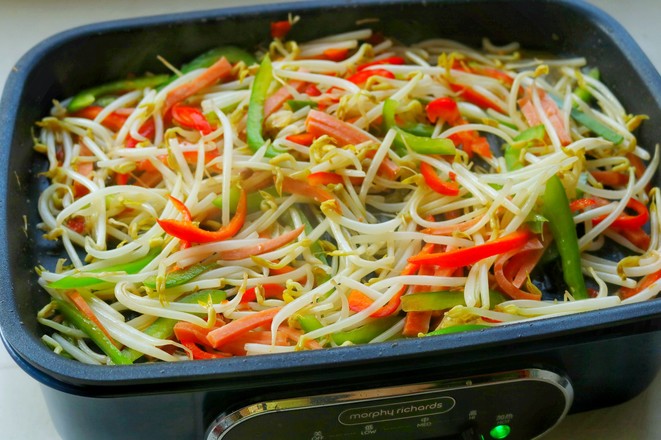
[{"left": 35, "top": 23, "right": 661, "bottom": 364}]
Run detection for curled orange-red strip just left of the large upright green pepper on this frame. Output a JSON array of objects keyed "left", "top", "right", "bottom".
[{"left": 494, "top": 238, "right": 544, "bottom": 300}]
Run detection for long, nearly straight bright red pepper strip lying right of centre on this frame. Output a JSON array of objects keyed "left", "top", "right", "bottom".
[{"left": 409, "top": 230, "right": 532, "bottom": 267}]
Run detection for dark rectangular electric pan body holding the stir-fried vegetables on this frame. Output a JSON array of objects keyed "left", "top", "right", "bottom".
[{"left": 0, "top": 0, "right": 661, "bottom": 439}]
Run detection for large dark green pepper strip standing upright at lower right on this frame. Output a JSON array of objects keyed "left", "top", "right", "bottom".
[{"left": 542, "top": 176, "right": 588, "bottom": 299}]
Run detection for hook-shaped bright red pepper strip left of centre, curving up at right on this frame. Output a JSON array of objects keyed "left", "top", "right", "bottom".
[{"left": 157, "top": 189, "right": 248, "bottom": 243}]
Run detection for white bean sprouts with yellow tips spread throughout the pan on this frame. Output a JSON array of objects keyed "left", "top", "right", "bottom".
[{"left": 35, "top": 24, "right": 661, "bottom": 364}]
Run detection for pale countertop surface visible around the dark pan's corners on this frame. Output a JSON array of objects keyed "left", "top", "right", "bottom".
[{"left": 0, "top": 0, "right": 661, "bottom": 440}]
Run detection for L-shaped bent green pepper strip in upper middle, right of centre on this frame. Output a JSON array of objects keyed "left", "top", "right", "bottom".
[{"left": 383, "top": 99, "right": 457, "bottom": 156}]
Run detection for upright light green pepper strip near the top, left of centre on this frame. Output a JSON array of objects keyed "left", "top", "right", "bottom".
[{"left": 246, "top": 55, "right": 280, "bottom": 157}]
